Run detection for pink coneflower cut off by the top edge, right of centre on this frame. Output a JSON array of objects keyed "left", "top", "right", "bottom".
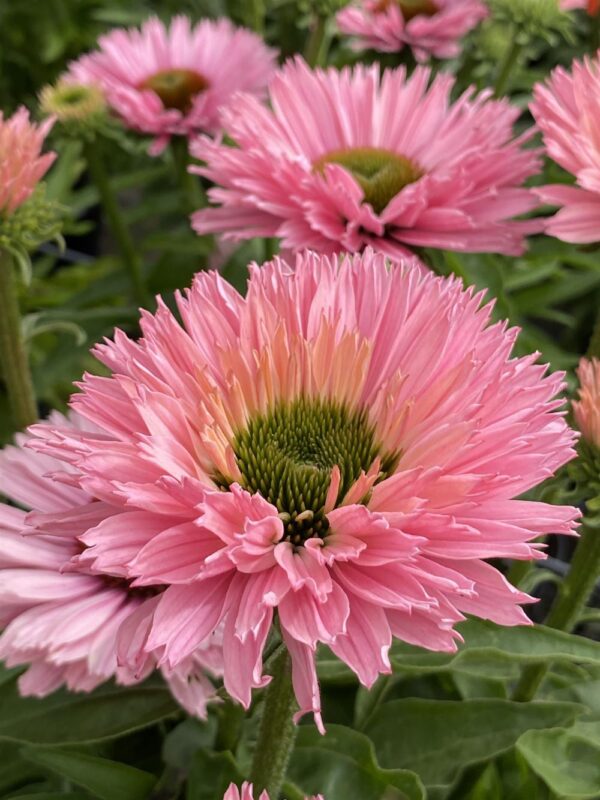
[{"left": 336, "top": 0, "right": 489, "bottom": 61}]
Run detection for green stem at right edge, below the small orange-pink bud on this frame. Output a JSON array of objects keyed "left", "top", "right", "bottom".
[{"left": 512, "top": 522, "right": 600, "bottom": 702}]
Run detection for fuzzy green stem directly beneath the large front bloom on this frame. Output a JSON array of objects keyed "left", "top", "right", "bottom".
[{"left": 252, "top": 650, "right": 297, "bottom": 800}]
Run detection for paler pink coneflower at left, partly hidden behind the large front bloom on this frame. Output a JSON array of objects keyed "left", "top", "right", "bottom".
[{"left": 0, "top": 414, "right": 222, "bottom": 716}]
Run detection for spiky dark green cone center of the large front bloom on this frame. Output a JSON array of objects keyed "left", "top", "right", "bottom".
[{"left": 225, "top": 397, "right": 397, "bottom": 545}]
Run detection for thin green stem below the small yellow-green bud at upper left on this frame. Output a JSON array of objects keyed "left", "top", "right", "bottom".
[{"left": 84, "top": 140, "right": 149, "bottom": 306}]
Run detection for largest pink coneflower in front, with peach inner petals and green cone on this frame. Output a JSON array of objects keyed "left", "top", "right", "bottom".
[{"left": 29, "top": 251, "right": 578, "bottom": 727}]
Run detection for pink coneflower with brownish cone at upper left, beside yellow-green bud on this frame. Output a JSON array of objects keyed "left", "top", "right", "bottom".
[{"left": 68, "top": 16, "right": 275, "bottom": 155}]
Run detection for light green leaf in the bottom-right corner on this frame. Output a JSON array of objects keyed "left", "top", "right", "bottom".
[{"left": 517, "top": 718, "right": 600, "bottom": 800}]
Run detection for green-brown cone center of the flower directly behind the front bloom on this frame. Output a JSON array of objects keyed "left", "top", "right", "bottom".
[{"left": 314, "top": 147, "right": 423, "bottom": 214}]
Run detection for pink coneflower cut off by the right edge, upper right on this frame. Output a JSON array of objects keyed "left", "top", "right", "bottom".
[{"left": 530, "top": 57, "right": 600, "bottom": 243}]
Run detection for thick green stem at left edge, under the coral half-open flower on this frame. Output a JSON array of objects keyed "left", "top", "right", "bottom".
[{"left": 0, "top": 248, "right": 38, "bottom": 430}]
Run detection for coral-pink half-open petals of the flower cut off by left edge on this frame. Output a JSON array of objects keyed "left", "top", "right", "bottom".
[{"left": 0, "top": 107, "right": 56, "bottom": 215}]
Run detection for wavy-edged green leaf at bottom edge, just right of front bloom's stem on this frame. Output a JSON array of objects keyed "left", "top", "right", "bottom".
[{"left": 288, "top": 725, "right": 425, "bottom": 800}]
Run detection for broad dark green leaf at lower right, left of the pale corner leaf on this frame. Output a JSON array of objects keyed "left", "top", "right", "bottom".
[{"left": 365, "top": 698, "right": 583, "bottom": 786}]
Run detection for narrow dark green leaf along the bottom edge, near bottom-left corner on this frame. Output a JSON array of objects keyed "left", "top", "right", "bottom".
[{"left": 22, "top": 747, "right": 156, "bottom": 800}]
